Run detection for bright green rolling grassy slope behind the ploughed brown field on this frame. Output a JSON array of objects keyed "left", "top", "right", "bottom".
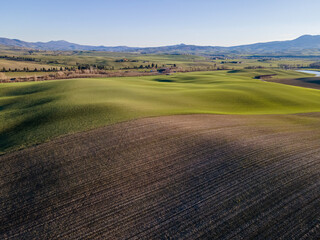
[{"left": 0, "top": 70, "right": 320, "bottom": 152}]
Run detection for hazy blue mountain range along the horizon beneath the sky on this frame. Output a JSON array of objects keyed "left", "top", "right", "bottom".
[{"left": 0, "top": 35, "right": 320, "bottom": 54}]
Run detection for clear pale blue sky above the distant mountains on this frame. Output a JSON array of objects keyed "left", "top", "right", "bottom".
[{"left": 0, "top": 0, "right": 320, "bottom": 47}]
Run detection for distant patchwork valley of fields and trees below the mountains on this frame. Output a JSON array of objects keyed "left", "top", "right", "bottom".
[{"left": 0, "top": 47, "right": 318, "bottom": 74}]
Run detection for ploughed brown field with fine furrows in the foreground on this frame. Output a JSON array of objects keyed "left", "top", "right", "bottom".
[{"left": 0, "top": 114, "right": 320, "bottom": 239}]
